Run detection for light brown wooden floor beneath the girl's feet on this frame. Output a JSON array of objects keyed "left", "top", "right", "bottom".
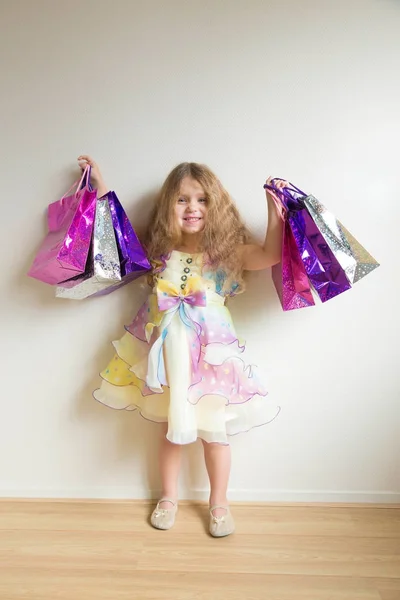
[{"left": 0, "top": 500, "right": 400, "bottom": 600}]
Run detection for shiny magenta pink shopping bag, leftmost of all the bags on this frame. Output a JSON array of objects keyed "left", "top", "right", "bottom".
[{"left": 28, "top": 167, "right": 97, "bottom": 285}]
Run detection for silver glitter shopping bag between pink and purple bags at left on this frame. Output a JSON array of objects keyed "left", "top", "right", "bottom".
[{"left": 56, "top": 196, "right": 121, "bottom": 300}]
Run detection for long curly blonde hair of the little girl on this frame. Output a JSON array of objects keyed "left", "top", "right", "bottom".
[{"left": 144, "top": 162, "right": 249, "bottom": 294}]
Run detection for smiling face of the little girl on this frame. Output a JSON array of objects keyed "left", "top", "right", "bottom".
[{"left": 175, "top": 177, "right": 208, "bottom": 235}]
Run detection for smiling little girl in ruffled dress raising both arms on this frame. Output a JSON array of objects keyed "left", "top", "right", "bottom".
[{"left": 78, "top": 155, "right": 282, "bottom": 537}]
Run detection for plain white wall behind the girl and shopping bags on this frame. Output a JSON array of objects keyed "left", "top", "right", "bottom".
[{"left": 0, "top": 0, "right": 400, "bottom": 502}]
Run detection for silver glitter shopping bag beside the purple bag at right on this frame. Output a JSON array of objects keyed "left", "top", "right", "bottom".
[{"left": 303, "top": 196, "right": 379, "bottom": 284}]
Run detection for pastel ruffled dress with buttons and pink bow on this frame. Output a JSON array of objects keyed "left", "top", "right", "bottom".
[{"left": 94, "top": 251, "right": 271, "bottom": 444}]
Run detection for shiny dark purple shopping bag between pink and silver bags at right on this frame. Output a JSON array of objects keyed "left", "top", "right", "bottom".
[{"left": 264, "top": 179, "right": 351, "bottom": 302}]
